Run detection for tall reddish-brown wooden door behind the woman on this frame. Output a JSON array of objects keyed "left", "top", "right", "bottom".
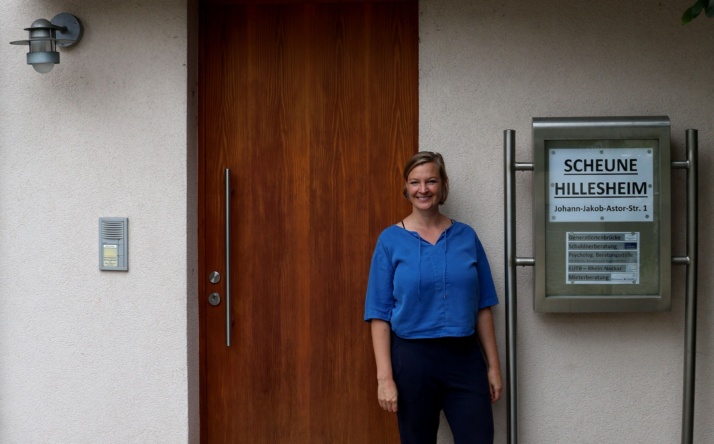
[{"left": 199, "top": 0, "right": 418, "bottom": 444}]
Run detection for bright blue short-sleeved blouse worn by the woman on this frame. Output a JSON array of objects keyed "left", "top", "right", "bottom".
[{"left": 364, "top": 222, "right": 498, "bottom": 339}]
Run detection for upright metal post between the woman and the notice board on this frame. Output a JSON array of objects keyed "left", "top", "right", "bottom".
[{"left": 503, "top": 130, "right": 518, "bottom": 444}]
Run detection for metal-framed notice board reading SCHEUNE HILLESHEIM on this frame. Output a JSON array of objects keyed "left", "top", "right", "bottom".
[{"left": 533, "top": 117, "right": 671, "bottom": 312}]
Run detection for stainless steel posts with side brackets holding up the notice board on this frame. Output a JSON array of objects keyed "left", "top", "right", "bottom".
[{"left": 503, "top": 125, "right": 699, "bottom": 444}]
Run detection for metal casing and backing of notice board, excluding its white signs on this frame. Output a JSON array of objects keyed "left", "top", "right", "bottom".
[{"left": 533, "top": 116, "right": 672, "bottom": 313}]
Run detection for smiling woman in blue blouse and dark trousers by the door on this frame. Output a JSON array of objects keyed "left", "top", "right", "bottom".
[{"left": 364, "top": 151, "right": 503, "bottom": 444}]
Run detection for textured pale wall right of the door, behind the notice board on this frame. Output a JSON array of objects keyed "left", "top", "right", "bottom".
[{"left": 420, "top": 0, "right": 714, "bottom": 444}]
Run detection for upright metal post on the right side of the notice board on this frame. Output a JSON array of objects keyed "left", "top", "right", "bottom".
[{"left": 682, "top": 129, "right": 699, "bottom": 444}]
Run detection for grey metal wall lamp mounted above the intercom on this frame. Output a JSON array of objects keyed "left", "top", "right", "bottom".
[{"left": 10, "top": 12, "right": 84, "bottom": 74}]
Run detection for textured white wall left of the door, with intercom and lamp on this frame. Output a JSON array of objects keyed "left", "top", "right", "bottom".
[{"left": 0, "top": 0, "right": 197, "bottom": 443}]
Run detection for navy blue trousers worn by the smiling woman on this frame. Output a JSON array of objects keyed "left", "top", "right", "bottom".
[{"left": 391, "top": 334, "right": 493, "bottom": 444}]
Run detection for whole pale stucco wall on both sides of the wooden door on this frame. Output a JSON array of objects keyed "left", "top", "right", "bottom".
[{"left": 0, "top": 0, "right": 714, "bottom": 444}]
